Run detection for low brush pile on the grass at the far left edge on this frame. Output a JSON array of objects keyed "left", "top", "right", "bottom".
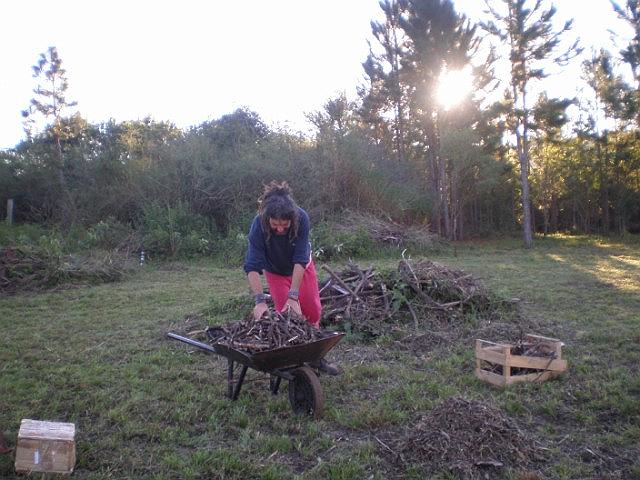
[{"left": 0, "top": 247, "right": 126, "bottom": 294}]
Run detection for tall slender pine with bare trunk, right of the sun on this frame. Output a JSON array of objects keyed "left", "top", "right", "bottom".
[{"left": 483, "top": 0, "right": 580, "bottom": 248}]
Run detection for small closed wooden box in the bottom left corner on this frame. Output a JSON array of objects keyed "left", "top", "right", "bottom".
[{"left": 15, "top": 418, "right": 76, "bottom": 474}]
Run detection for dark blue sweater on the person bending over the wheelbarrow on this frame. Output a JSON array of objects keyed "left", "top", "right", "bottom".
[{"left": 244, "top": 207, "right": 311, "bottom": 277}]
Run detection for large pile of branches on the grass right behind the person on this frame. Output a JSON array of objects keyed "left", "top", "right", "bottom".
[{"left": 320, "top": 260, "right": 493, "bottom": 335}]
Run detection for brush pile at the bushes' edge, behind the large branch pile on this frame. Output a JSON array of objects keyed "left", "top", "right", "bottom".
[{"left": 336, "top": 210, "right": 437, "bottom": 248}]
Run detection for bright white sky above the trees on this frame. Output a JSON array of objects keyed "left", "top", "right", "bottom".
[{"left": 0, "top": 0, "right": 629, "bottom": 149}]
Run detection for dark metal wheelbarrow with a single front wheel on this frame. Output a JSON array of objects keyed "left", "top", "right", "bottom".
[{"left": 167, "top": 328, "right": 345, "bottom": 419}]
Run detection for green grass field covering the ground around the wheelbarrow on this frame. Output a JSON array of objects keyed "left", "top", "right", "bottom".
[{"left": 0, "top": 237, "right": 640, "bottom": 479}]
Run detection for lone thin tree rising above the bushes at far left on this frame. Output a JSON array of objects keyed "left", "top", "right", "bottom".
[{"left": 22, "top": 47, "right": 77, "bottom": 226}]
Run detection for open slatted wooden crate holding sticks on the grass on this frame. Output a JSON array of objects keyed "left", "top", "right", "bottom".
[{"left": 475, "top": 334, "right": 567, "bottom": 387}]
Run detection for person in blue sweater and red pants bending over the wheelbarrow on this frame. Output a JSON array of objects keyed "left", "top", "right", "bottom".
[{"left": 244, "top": 181, "right": 338, "bottom": 375}]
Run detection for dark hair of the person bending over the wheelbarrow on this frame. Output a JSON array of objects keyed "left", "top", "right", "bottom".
[{"left": 258, "top": 180, "right": 299, "bottom": 243}]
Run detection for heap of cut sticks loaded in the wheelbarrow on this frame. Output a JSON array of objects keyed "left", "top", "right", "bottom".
[{"left": 206, "top": 310, "right": 326, "bottom": 353}]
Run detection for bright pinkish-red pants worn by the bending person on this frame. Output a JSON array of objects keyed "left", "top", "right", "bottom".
[{"left": 264, "top": 260, "right": 322, "bottom": 327}]
